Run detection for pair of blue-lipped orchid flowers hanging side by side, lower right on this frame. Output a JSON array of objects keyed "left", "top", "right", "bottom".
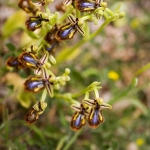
[{"left": 70, "top": 82, "right": 112, "bottom": 131}]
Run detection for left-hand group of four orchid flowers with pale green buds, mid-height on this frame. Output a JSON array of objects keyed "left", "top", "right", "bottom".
[{"left": 6, "top": 46, "right": 70, "bottom": 124}]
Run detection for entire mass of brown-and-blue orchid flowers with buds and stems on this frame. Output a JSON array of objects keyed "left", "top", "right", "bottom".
[{"left": 7, "top": 0, "right": 125, "bottom": 130}]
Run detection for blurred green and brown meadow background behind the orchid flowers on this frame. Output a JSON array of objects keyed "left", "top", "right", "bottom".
[{"left": 0, "top": 0, "right": 150, "bottom": 150}]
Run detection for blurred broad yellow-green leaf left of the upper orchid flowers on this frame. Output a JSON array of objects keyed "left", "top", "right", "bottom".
[{"left": 2, "top": 10, "right": 26, "bottom": 38}]
